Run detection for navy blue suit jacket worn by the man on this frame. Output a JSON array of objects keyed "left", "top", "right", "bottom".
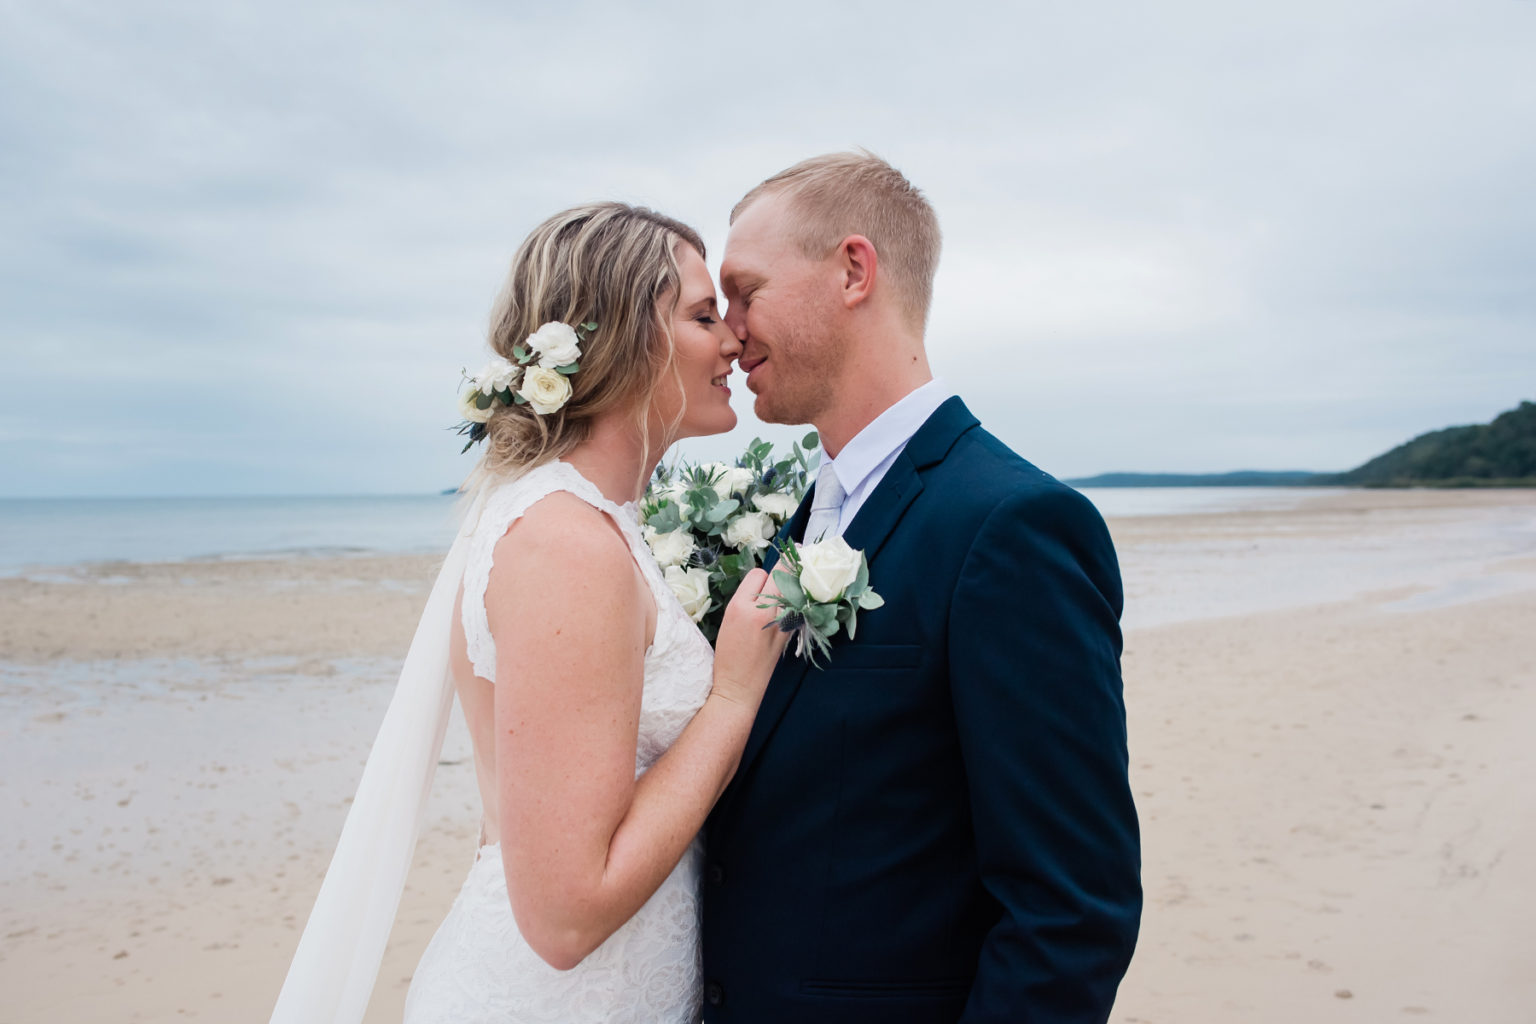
[{"left": 703, "top": 398, "right": 1141, "bottom": 1024}]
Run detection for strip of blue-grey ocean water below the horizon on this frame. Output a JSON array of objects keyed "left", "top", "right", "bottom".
[{"left": 0, "top": 487, "right": 1318, "bottom": 576}]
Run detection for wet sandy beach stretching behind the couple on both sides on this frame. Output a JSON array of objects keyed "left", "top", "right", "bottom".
[{"left": 0, "top": 491, "right": 1536, "bottom": 1024}]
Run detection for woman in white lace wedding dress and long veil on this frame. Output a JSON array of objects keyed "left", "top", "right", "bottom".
[{"left": 272, "top": 203, "right": 783, "bottom": 1024}]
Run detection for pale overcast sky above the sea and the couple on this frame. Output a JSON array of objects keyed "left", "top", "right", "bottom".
[{"left": 0, "top": 0, "right": 1536, "bottom": 496}]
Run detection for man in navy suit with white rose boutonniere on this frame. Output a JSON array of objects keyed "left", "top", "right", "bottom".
[{"left": 703, "top": 154, "right": 1141, "bottom": 1024}]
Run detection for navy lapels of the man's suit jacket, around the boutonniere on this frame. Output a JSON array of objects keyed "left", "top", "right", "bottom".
[{"left": 727, "top": 398, "right": 977, "bottom": 800}]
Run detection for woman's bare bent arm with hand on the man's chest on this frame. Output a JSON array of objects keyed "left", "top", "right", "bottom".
[{"left": 485, "top": 496, "right": 783, "bottom": 970}]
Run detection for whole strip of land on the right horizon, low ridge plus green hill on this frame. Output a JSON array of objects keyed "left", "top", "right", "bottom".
[{"left": 1066, "top": 402, "right": 1536, "bottom": 487}]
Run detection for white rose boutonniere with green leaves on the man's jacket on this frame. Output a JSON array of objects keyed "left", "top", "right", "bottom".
[{"left": 752, "top": 537, "right": 885, "bottom": 666}]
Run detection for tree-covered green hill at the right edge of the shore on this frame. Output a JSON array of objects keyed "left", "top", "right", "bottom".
[{"left": 1316, "top": 402, "right": 1536, "bottom": 487}]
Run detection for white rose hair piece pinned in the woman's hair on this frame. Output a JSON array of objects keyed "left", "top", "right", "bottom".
[{"left": 459, "top": 321, "right": 598, "bottom": 451}]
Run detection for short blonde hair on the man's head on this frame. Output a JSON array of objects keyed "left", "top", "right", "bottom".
[{"left": 731, "top": 150, "right": 942, "bottom": 330}]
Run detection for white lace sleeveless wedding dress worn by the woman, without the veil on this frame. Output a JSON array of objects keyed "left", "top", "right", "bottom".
[{"left": 406, "top": 462, "right": 713, "bottom": 1024}]
